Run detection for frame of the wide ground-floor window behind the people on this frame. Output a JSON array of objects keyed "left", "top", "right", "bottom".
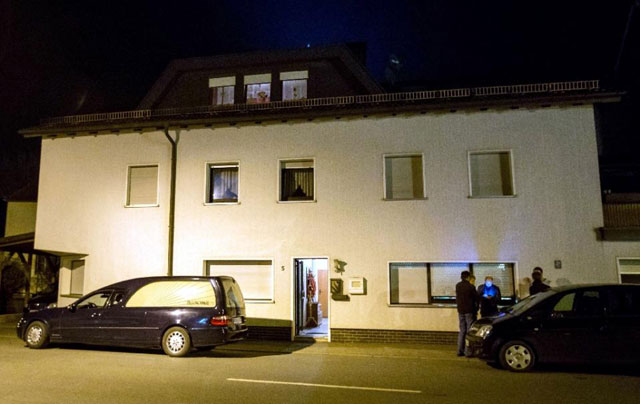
[{"left": 386, "top": 260, "right": 519, "bottom": 308}]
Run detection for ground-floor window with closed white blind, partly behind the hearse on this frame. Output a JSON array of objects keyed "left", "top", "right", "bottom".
[{"left": 205, "top": 260, "right": 274, "bottom": 302}]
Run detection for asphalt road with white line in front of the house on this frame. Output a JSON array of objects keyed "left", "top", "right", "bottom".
[{"left": 0, "top": 324, "right": 640, "bottom": 404}]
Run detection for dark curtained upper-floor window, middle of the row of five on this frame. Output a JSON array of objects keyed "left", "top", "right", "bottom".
[{"left": 280, "top": 159, "right": 315, "bottom": 202}]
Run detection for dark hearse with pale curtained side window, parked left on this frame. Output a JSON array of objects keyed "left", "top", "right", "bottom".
[{"left": 17, "top": 276, "right": 247, "bottom": 356}]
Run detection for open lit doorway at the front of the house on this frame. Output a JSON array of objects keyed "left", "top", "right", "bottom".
[{"left": 293, "top": 258, "right": 329, "bottom": 338}]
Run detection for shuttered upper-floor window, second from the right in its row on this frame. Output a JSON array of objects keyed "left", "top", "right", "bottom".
[{"left": 384, "top": 154, "right": 425, "bottom": 200}]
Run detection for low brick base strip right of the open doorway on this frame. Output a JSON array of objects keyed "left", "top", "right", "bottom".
[{"left": 331, "top": 328, "right": 458, "bottom": 345}]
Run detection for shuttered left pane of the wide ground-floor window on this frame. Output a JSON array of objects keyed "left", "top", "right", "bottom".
[{"left": 389, "top": 263, "right": 429, "bottom": 304}]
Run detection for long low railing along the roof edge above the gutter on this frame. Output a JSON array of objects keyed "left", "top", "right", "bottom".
[{"left": 41, "top": 80, "right": 600, "bottom": 126}]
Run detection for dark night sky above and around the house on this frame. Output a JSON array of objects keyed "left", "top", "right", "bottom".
[{"left": 0, "top": 0, "right": 640, "bottom": 197}]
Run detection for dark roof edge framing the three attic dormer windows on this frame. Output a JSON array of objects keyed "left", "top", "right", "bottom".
[{"left": 138, "top": 45, "right": 384, "bottom": 109}]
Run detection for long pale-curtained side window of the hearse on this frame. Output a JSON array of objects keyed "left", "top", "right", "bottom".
[{"left": 126, "top": 281, "right": 216, "bottom": 307}]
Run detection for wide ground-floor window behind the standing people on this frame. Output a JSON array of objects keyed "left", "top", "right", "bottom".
[{"left": 389, "top": 262, "right": 516, "bottom": 305}]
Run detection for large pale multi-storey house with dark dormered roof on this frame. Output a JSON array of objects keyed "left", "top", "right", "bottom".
[{"left": 23, "top": 47, "right": 640, "bottom": 342}]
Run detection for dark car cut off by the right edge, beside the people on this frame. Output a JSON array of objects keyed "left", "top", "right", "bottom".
[{"left": 466, "top": 284, "right": 640, "bottom": 371}]
